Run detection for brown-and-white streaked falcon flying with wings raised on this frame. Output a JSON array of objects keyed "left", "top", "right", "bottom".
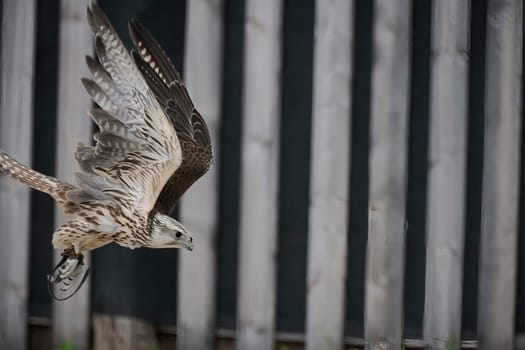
[{"left": 0, "top": 4, "right": 213, "bottom": 299}]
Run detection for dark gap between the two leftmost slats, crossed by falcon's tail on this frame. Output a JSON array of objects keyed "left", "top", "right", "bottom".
[{"left": 29, "top": 0, "right": 59, "bottom": 317}]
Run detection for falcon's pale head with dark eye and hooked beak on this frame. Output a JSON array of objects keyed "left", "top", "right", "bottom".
[{"left": 148, "top": 212, "right": 193, "bottom": 251}]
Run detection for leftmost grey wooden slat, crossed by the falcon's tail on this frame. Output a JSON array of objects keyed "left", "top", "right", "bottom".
[{"left": 0, "top": 0, "right": 36, "bottom": 349}]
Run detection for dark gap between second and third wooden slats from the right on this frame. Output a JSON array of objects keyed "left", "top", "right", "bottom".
[{"left": 404, "top": 1, "right": 432, "bottom": 338}]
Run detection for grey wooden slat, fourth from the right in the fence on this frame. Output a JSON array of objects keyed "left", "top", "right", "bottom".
[{"left": 306, "top": 0, "right": 353, "bottom": 350}]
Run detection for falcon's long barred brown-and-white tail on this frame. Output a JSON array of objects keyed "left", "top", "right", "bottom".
[{"left": 0, "top": 151, "right": 76, "bottom": 202}]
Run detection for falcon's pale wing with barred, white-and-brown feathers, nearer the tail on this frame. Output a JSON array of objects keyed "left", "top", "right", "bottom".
[{"left": 68, "top": 4, "right": 182, "bottom": 214}]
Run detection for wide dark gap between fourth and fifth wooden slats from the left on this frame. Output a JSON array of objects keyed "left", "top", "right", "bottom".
[{"left": 277, "top": 0, "right": 315, "bottom": 332}]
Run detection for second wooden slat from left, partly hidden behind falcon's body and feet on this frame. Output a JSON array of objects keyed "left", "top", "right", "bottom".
[{"left": 53, "top": 0, "right": 93, "bottom": 350}]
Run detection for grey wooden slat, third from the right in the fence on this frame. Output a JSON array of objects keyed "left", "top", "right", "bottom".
[{"left": 365, "top": 0, "right": 411, "bottom": 349}]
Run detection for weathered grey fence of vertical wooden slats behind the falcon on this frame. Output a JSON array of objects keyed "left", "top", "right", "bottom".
[{"left": 0, "top": 0, "right": 525, "bottom": 350}]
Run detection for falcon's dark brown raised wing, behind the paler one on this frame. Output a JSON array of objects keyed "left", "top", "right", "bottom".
[{"left": 129, "top": 19, "right": 213, "bottom": 214}]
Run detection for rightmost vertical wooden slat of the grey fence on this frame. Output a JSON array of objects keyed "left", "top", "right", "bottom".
[{"left": 478, "top": 0, "right": 523, "bottom": 350}]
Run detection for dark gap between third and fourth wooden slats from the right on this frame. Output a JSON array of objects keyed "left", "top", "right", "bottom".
[{"left": 345, "top": 0, "right": 373, "bottom": 337}]
